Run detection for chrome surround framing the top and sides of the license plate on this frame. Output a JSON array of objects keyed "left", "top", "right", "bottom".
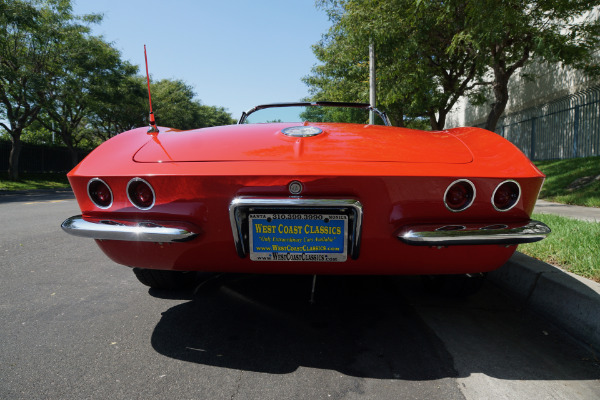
[{"left": 229, "top": 196, "right": 363, "bottom": 259}]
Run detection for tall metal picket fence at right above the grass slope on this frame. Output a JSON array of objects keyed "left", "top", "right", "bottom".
[{"left": 481, "top": 86, "right": 600, "bottom": 160}]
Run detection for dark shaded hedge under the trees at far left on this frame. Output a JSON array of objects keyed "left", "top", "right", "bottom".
[{"left": 0, "top": 141, "right": 89, "bottom": 173}]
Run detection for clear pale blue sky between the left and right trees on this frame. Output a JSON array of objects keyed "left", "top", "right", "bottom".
[{"left": 73, "top": 0, "right": 330, "bottom": 119}]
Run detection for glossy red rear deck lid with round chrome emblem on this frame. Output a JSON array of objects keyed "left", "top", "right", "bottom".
[{"left": 134, "top": 123, "right": 473, "bottom": 164}]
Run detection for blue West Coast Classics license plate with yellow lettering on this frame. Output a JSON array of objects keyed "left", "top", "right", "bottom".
[{"left": 248, "top": 213, "right": 348, "bottom": 262}]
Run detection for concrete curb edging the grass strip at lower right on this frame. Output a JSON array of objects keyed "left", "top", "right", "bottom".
[{"left": 488, "top": 252, "right": 600, "bottom": 351}]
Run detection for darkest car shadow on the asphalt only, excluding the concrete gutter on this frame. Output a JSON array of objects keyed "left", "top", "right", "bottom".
[{"left": 152, "top": 275, "right": 456, "bottom": 380}]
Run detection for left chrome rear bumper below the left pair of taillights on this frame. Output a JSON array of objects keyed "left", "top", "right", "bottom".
[{"left": 61, "top": 215, "right": 198, "bottom": 243}]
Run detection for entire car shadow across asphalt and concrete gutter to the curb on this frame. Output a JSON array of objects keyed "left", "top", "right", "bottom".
[{"left": 152, "top": 275, "right": 600, "bottom": 381}]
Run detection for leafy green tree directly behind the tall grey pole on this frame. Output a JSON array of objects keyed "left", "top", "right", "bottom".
[{"left": 305, "top": 0, "right": 483, "bottom": 129}]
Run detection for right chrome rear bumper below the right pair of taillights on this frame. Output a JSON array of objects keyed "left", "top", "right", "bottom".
[{"left": 397, "top": 220, "right": 551, "bottom": 246}]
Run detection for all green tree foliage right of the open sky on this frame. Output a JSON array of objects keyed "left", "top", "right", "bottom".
[{"left": 304, "top": 0, "right": 600, "bottom": 130}]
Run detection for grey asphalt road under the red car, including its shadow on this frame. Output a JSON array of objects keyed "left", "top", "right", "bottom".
[{"left": 0, "top": 193, "right": 600, "bottom": 400}]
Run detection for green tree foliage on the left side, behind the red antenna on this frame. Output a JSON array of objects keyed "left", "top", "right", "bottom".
[{"left": 0, "top": 0, "right": 233, "bottom": 179}]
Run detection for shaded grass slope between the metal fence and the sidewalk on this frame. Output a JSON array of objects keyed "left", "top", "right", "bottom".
[{"left": 535, "top": 157, "right": 600, "bottom": 207}]
